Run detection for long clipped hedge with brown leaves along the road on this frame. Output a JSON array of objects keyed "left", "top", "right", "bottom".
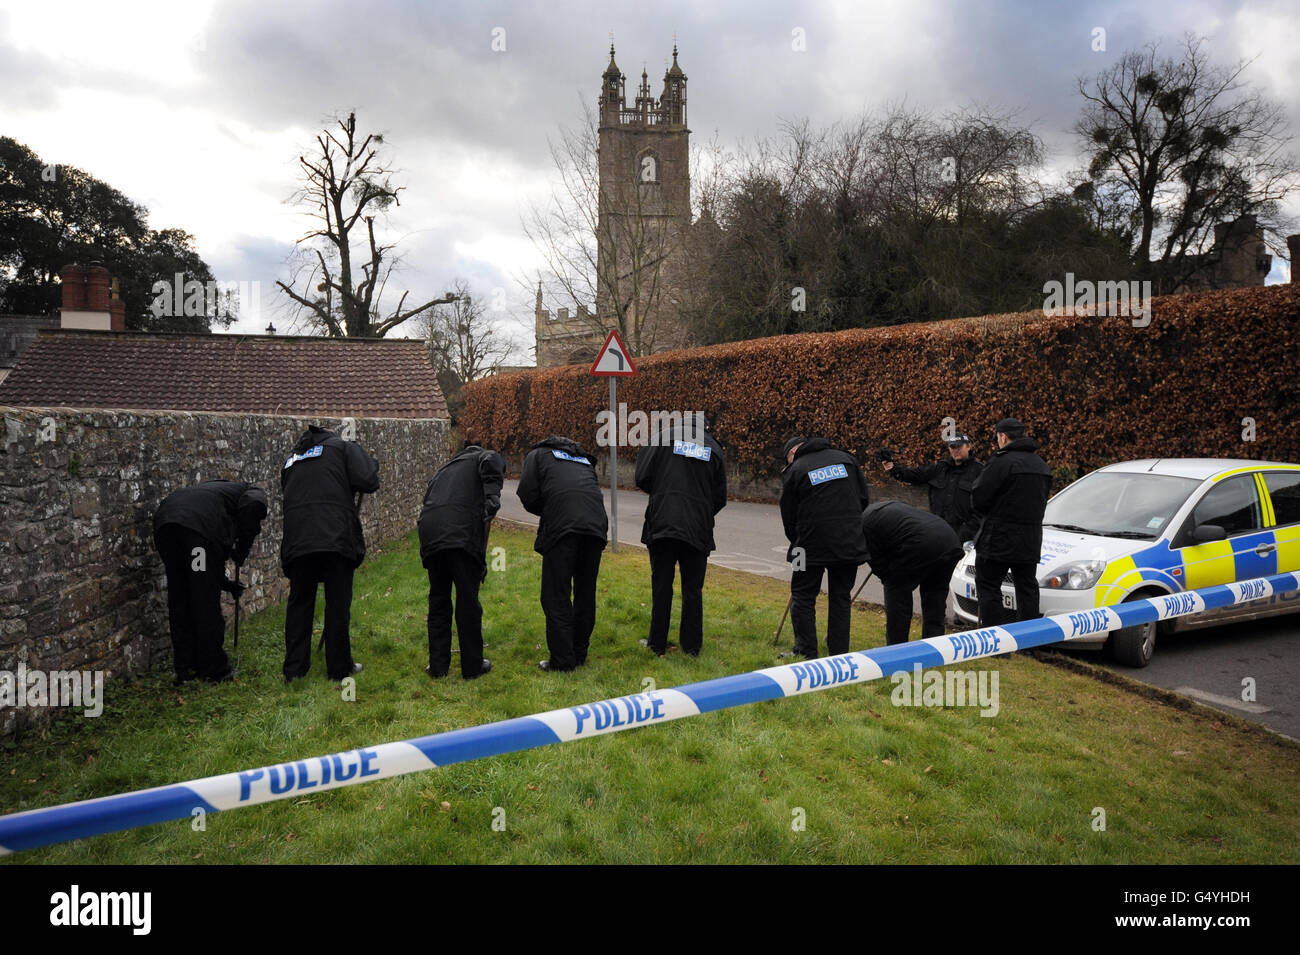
[{"left": 460, "top": 283, "right": 1300, "bottom": 479}]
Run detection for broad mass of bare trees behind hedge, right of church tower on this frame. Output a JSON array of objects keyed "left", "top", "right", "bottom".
[{"left": 692, "top": 105, "right": 1043, "bottom": 340}]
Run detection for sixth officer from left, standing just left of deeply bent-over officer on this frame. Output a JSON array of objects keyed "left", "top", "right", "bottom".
[{"left": 781, "top": 435, "right": 868, "bottom": 659}]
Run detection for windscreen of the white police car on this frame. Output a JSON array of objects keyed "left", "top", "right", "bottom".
[{"left": 1043, "top": 470, "right": 1201, "bottom": 541}]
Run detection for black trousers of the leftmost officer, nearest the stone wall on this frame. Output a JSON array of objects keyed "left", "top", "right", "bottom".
[{"left": 153, "top": 524, "right": 230, "bottom": 680}]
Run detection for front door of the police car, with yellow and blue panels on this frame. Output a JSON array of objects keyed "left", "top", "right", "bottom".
[{"left": 1175, "top": 473, "right": 1278, "bottom": 625}]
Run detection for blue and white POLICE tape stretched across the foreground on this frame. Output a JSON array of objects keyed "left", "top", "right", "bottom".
[{"left": 0, "top": 573, "right": 1300, "bottom": 855}]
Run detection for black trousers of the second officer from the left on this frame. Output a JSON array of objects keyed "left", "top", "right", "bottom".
[{"left": 285, "top": 552, "right": 355, "bottom": 680}]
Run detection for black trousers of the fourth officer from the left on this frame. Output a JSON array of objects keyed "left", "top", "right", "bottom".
[{"left": 542, "top": 534, "right": 605, "bottom": 670}]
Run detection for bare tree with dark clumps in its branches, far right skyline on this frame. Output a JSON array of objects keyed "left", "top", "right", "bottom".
[{"left": 1075, "top": 35, "right": 1297, "bottom": 291}]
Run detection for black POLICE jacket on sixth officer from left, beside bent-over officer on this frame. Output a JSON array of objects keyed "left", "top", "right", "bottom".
[{"left": 781, "top": 438, "right": 870, "bottom": 567}]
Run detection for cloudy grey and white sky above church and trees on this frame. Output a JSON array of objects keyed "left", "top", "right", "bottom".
[{"left": 0, "top": 0, "right": 1300, "bottom": 356}]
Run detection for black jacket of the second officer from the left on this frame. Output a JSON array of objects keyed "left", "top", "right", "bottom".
[{"left": 280, "top": 425, "right": 380, "bottom": 573}]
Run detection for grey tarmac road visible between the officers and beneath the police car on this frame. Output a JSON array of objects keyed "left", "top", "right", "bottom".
[{"left": 501, "top": 481, "right": 1300, "bottom": 739}]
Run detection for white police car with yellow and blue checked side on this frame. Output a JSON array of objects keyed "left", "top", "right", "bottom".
[{"left": 950, "top": 457, "right": 1300, "bottom": 667}]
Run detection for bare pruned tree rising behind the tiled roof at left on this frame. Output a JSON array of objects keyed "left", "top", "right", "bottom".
[{"left": 276, "top": 112, "right": 455, "bottom": 338}]
